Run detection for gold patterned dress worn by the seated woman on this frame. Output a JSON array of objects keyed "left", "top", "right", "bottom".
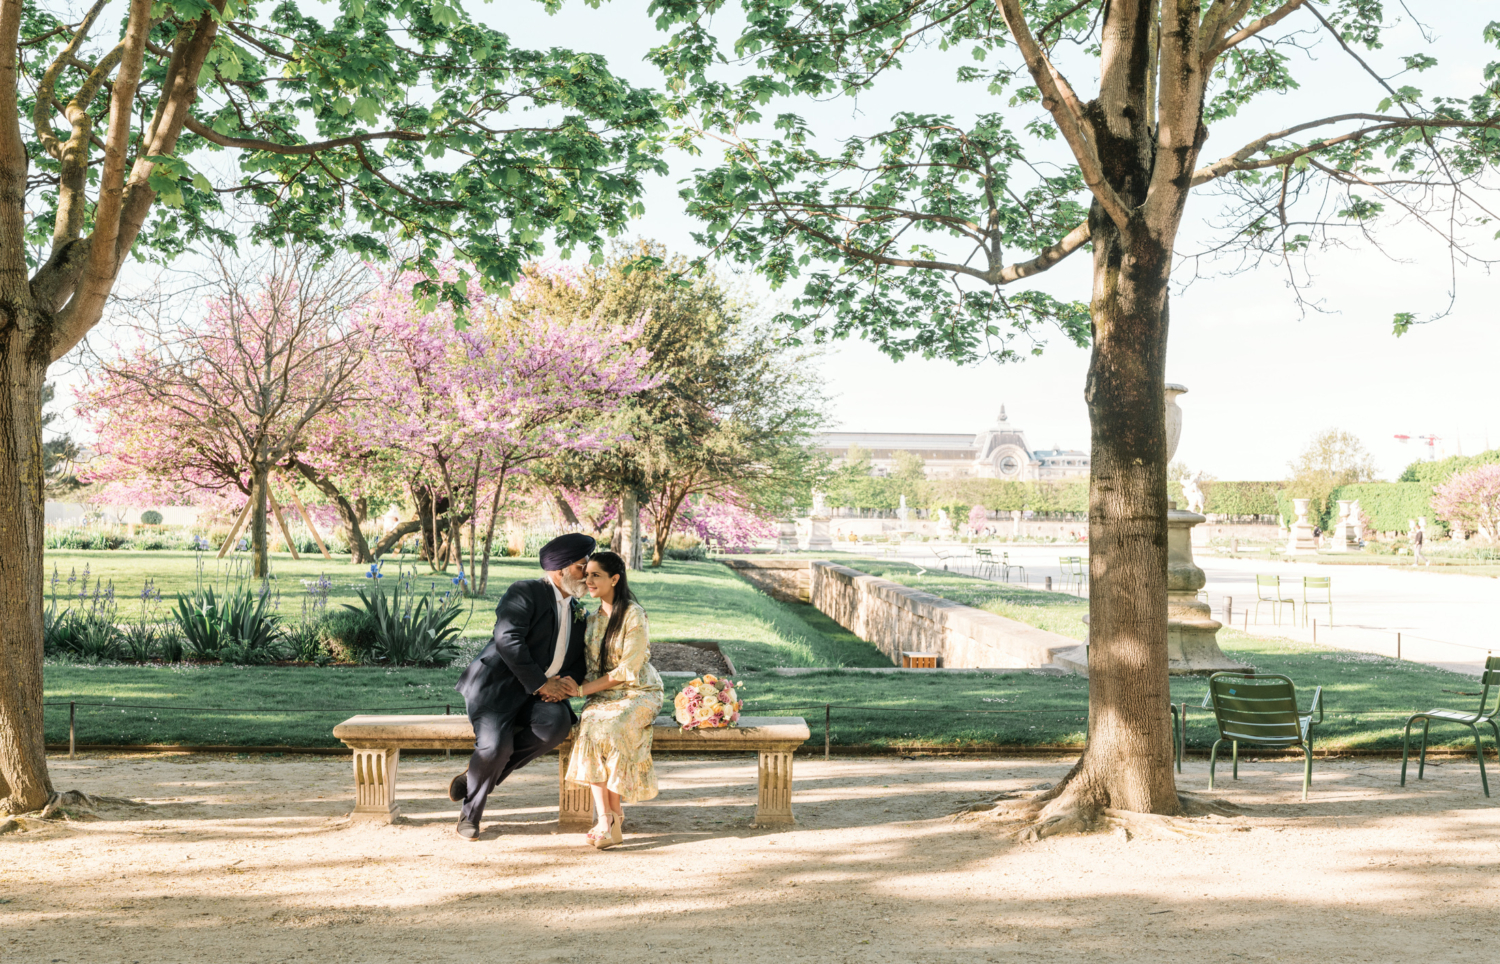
[{"left": 567, "top": 603, "right": 662, "bottom": 804}]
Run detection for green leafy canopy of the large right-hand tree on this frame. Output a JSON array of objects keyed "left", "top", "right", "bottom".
[{"left": 651, "top": 0, "right": 1500, "bottom": 361}]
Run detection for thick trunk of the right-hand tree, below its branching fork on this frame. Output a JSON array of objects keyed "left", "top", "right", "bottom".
[{"left": 1037, "top": 205, "right": 1181, "bottom": 835}]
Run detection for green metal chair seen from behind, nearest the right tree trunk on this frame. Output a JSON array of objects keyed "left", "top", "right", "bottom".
[{"left": 1206, "top": 673, "right": 1323, "bottom": 802}]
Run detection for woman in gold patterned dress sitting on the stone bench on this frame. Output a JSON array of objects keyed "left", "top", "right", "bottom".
[{"left": 567, "top": 552, "right": 662, "bottom": 850}]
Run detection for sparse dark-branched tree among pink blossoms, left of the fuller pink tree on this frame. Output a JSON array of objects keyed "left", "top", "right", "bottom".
[{"left": 80, "top": 249, "right": 378, "bottom": 577}]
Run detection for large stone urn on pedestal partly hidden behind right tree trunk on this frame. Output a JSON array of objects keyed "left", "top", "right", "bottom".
[{"left": 1167, "top": 384, "right": 1248, "bottom": 675}]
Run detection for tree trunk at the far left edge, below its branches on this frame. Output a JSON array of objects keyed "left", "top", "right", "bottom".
[{"left": 0, "top": 343, "right": 53, "bottom": 814}]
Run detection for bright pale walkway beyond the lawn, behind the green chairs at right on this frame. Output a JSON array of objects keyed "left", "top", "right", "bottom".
[{"left": 864, "top": 543, "right": 1500, "bottom": 676}]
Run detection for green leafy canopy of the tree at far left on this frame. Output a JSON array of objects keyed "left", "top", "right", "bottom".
[{"left": 20, "top": 0, "right": 665, "bottom": 304}]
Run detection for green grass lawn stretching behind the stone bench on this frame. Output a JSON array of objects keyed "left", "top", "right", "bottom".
[{"left": 38, "top": 552, "right": 1478, "bottom": 748}]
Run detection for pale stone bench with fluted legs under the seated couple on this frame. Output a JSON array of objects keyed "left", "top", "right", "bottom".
[{"left": 333, "top": 717, "right": 810, "bottom": 831}]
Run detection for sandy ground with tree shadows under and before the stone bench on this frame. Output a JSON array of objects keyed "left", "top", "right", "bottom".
[{"left": 0, "top": 756, "right": 1500, "bottom": 964}]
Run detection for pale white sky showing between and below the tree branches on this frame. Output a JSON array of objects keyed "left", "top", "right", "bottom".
[{"left": 65, "top": 0, "right": 1500, "bottom": 480}]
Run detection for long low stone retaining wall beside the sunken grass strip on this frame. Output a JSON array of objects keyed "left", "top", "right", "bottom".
[{"left": 810, "top": 561, "right": 1079, "bottom": 669}]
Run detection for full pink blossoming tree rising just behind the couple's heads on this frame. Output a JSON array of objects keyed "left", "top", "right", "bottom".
[{"left": 362, "top": 268, "right": 653, "bottom": 592}]
